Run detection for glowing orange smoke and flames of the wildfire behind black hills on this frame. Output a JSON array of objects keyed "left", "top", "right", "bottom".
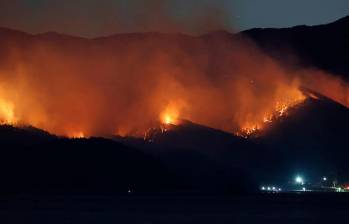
[{"left": 0, "top": 26, "right": 346, "bottom": 138}]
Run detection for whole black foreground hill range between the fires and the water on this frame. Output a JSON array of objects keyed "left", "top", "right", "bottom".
[{"left": 0, "top": 90, "right": 349, "bottom": 193}]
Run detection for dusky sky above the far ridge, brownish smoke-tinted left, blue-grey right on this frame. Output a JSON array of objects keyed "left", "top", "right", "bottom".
[{"left": 0, "top": 0, "right": 349, "bottom": 37}]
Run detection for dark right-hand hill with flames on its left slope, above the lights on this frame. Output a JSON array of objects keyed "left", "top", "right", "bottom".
[{"left": 252, "top": 89, "right": 349, "bottom": 184}]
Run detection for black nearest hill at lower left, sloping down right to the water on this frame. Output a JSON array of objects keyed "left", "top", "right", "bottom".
[{"left": 0, "top": 126, "right": 181, "bottom": 194}]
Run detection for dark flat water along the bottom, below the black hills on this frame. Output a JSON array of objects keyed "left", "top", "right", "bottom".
[{"left": 0, "top": 194, "right": 349, "bottom": 224}]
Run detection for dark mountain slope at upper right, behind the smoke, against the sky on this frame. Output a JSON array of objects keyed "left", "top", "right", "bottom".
[{"left": 239, "top": 16, "right": 349, "bottom": 79}]
